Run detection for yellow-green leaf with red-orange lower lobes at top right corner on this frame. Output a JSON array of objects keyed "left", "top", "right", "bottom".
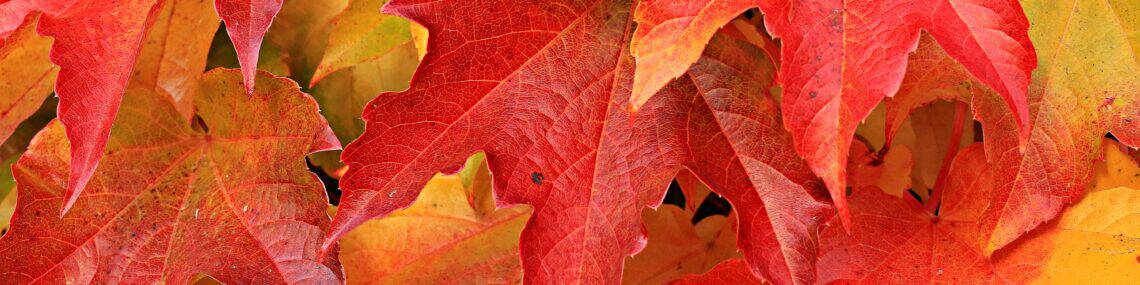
[{"left": 893, "top": 0, "right": 1140, "bottom": 254}]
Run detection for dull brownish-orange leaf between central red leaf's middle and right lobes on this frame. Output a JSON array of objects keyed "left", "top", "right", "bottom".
[{"left": 624, "top": 204, "right": 738, "bottom": 284}]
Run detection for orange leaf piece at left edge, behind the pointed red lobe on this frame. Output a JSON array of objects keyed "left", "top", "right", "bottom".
[{"left": 0, "top": 15, "right": 59, "bottom": 147}]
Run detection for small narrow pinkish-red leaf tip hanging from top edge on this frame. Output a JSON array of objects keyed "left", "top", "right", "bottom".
[{"left": 214, "top": 0, "right": 284, "bottom": 93}]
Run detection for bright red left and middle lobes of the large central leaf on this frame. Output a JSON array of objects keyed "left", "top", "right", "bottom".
[{"left": 327, "top": 0, "right": 656, "bottom": 283}]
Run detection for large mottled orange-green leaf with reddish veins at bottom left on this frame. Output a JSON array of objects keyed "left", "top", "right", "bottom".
[{"left": 0, "top": 71, "right": 341, "bottom": 284}]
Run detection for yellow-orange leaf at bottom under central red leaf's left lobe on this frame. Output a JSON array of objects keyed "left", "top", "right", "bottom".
[{"left": 340, "top": 156, "right": 530, "bottom": 284}]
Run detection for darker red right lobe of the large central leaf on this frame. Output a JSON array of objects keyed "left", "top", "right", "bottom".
[{"left": 637, "top": 27, "right": 832, "bottom": 284}]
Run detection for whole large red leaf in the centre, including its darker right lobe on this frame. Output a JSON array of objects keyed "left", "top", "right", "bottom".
[{"left": 326, "top": 0, "right": 828, "bottom": 283}]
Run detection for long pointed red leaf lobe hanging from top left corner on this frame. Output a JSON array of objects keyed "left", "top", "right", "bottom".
[{"left": 0, "top": 0, "right": 163, "bottom": 213}]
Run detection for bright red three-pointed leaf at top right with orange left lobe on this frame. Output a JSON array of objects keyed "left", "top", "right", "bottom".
[{"left": 634, "top": 0, "right": 1036, "bottom": 224}]
